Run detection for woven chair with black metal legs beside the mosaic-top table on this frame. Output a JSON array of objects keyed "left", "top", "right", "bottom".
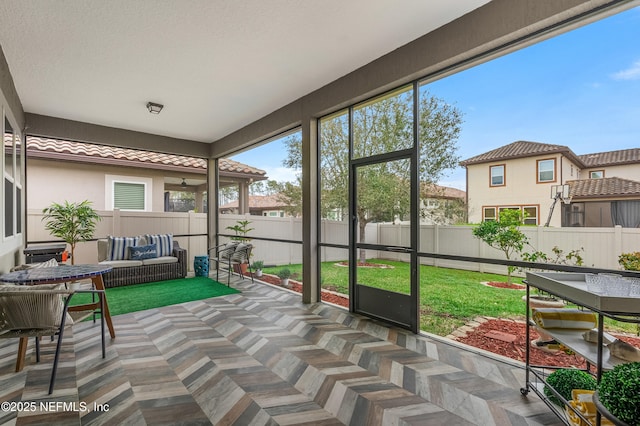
[{"left": 0, "top": 285, "right": 106, "bottom": 394}]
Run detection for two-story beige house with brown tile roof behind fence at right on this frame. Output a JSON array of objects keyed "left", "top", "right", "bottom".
[{"left": 460, "top": 141, "right": 640, "bottom": 228}]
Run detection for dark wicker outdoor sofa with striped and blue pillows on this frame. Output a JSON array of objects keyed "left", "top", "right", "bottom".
[{"left": 98, "top": 234, "right": 187, "bottom": 288}]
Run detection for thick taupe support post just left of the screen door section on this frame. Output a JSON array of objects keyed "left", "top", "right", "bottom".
[{"left": 302, "top": 117, "right": 320, "bottom": 303}]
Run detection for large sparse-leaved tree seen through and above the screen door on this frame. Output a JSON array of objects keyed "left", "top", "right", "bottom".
[{"left": 283, "top": 91, "right": 462, "bottom": 261}]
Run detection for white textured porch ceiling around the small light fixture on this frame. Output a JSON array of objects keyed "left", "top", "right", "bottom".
[{"left": 0, "top": 0, "right": 488, "bottom": 150}]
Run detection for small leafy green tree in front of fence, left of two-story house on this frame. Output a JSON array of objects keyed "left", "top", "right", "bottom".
[{"left": 473, "top": 209, "right": 529, "bottom": 284}]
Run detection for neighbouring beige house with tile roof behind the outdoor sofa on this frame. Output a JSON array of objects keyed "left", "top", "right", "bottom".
[{"left": 26, "top": 136, "right": 267, "bottom": 213}]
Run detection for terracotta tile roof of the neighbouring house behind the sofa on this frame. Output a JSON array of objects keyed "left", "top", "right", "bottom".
[{"left": 27, "top": 136, "right": 266, "bottom": 177}]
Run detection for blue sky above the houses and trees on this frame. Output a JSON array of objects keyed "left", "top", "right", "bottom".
[{"left": 232, "top": 7, "right": 640, "bottom": 189}]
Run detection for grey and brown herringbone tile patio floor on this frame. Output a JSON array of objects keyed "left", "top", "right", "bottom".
[{"left": 0, "top": 278, "right": 560, "bottom": 426}]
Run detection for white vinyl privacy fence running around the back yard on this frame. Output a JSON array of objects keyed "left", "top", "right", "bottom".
[{"left": 27, "top": 210, "right": 640, "bottom": 273}]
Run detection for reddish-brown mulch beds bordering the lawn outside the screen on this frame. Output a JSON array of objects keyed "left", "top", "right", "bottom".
[{"left": 256, "top": 274, "right": 640, "bottom": 368}]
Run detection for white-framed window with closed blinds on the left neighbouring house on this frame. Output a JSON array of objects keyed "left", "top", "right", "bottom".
[{"left": 105, "top": 175, "right": 153, "bottom": 211}]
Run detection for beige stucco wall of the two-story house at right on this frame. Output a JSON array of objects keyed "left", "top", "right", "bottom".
[{"left": 467, "top": 154, "right": 579, "bottom": 227}]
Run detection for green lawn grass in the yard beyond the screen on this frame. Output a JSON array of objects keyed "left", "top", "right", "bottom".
[{"left": 264, "top": 259, "right": 636, "bottom": 336}]
